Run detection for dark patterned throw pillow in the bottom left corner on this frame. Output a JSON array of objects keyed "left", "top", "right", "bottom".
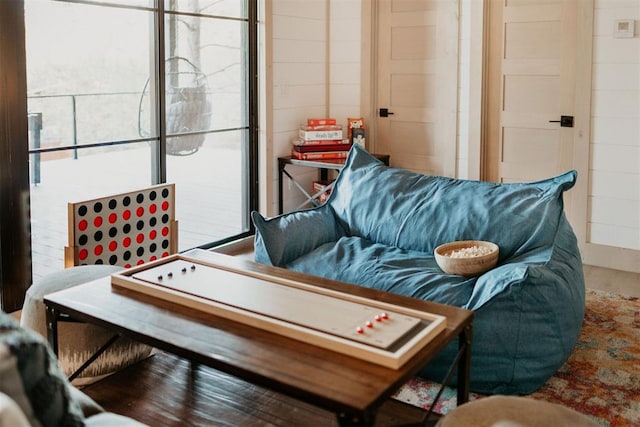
[{"left": 0, "top": 312, "right": 84, "bottom": 427}]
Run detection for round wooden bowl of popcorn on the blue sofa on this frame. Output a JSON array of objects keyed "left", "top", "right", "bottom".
[{"left": 433, "top": 240, "right": 499, "bottom": 277}]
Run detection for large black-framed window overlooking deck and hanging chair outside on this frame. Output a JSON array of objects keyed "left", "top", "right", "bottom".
[{"left": 24, "top": 0, "right": 257, "bottom": 279}]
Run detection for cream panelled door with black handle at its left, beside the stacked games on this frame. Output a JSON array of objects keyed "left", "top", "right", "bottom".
[{"left": 373, "top": 0, "right": 458, "bottom": 176}]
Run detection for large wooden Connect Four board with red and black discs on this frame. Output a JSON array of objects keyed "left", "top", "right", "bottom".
[{"left": 65, "top": 184, "right": 178, "bottom": 268}]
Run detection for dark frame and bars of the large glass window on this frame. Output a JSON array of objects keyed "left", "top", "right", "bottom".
[{"left": 0, "top": 0, "right": 259, "bottom": 311}]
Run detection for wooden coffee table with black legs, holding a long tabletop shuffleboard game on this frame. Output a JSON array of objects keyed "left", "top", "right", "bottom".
[{"left": 45, "top": 250, "right": 473, "bottom": 425}]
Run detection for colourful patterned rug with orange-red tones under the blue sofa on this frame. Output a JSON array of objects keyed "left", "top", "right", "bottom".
[{"left": 394, "top": 290, "right": 640, "bottom": 427}]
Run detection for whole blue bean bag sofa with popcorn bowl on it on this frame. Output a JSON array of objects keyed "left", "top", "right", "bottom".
[{"left": 252, "top": 146, "right": 585, "bottom": 394}]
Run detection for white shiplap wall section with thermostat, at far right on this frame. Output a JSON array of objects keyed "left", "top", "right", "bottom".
[{"left": 589, "top": 0, "right": 640, "bottom": 250}]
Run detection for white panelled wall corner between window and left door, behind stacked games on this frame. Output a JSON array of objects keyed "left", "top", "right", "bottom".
[{"left": 265, "top": 0, "right": 362, "bottom": 215}]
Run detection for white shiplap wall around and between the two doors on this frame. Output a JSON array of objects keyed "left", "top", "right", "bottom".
[{"left": 263, "top": 0, "right": 640, "bottom": 271}]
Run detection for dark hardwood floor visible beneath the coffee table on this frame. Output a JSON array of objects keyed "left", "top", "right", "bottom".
[{"left": 83, "top": 353, "right": 437, "bottom": 427}]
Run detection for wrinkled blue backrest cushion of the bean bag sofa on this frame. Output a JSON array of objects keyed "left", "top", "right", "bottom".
[{"left": 327, "top": 146, "right": 576, "bottom": 260}]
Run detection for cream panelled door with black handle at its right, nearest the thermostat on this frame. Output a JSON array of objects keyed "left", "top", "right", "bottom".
[{"left": 485, "top": 0, "right": 580, "bottom": 182}]
